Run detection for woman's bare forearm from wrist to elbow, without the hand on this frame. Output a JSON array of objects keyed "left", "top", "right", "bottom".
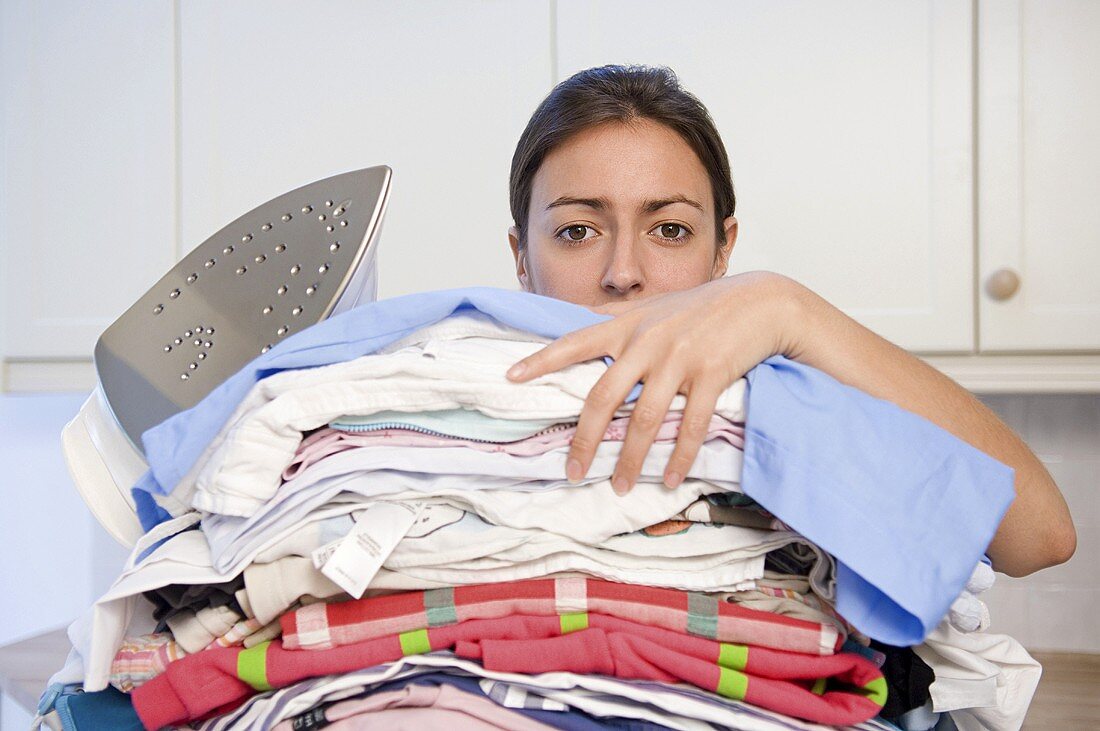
[{"left": 777, "top": 273, "right": 1077, "bottom": 576}]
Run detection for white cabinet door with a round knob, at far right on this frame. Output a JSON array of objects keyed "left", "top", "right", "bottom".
[{"left": 978, "top": 0, "right": 1100, "bottom": 351}]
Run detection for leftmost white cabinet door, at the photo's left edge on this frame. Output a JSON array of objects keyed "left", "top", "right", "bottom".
[{"left": 0, "top": 0, "right": 176, "bottom": 359}]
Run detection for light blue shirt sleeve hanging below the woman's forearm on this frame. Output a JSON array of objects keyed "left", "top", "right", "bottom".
[{"left": 741, "top": 356, "right": 1015, "bottom": 646}]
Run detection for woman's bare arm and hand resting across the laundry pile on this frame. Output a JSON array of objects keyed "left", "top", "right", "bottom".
[{"left": 508, "top": 272, "right": 1077, "bottom": 576}]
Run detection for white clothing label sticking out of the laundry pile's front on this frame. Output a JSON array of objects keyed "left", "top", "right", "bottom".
[{"left": 312, "top": 502, "right": 424, "bottom": 599}]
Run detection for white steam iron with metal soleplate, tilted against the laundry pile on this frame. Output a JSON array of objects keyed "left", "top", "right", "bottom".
[{"left": 62, "top": 165, "right": 393, "bottom": 546}]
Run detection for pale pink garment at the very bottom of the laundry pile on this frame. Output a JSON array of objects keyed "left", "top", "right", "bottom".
[{"left": 275, "top": 685, "right": 550, "bottom": 731}]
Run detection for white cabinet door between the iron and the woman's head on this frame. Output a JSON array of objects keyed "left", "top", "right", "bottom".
[{"left": 179, "top": 0, "right": 552, "bottom": 297}]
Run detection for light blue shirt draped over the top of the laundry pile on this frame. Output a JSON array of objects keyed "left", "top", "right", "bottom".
[{"left": 134, "top": 288, "right": 1014, "bottom": 646}]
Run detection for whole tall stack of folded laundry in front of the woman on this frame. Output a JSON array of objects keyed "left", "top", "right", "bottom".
[{"left": 41, "top": 289, "right": 1037, "bottom": 729}]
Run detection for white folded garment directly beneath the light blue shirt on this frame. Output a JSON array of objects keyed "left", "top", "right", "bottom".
[{"left": 184, "top": 325, "right": 744, "bottom": 517}]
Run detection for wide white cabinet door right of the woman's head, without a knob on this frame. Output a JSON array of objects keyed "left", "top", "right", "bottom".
[{"left": 556, "top": 0, "right": 975, "bottom": 352}]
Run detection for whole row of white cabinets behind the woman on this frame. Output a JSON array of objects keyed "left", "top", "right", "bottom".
[{"left": 0, "top": 0, "right": 1100, "bottom": 390}]
